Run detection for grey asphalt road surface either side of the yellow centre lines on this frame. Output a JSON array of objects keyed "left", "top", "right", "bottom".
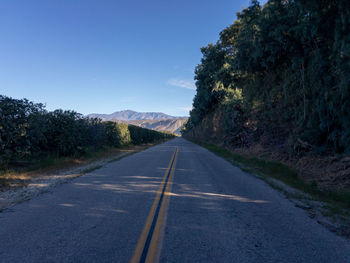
[{"left": 0, "top": 138, "right": 350, "bottom": 263}]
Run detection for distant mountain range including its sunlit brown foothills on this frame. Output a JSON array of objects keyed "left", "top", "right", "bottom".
[{"left": 87, "top": 110, "right": 188, "bottom": 135}]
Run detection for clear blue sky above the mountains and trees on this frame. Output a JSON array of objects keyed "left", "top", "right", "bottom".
[{"left": 0, "top": 0, "right": 258, "bottom": 116}]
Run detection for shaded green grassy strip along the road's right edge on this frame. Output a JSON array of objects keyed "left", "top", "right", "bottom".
[{"left": 187, "top": 140, "right": 350, "bottom": 239}]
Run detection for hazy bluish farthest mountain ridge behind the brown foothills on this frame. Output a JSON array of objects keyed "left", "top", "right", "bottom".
[{"left": 87, "top": 110, "right": 185, "bottom": 121}]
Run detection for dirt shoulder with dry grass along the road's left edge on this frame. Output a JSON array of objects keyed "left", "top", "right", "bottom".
[{"left": 0, "top": 144, "right": 154, "bottom": 212}]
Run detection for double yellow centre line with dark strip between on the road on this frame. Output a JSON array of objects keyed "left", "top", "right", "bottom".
[{"left": 130, "top": 147, "right": 178, "bottom": 263}]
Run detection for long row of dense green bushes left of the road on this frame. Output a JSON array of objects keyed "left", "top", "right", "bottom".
[{"left": 0, "top": 95, "right": 172, "bottom": 167}]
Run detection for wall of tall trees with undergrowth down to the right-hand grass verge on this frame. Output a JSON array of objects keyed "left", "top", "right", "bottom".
[{"left": 182, "top": 0, "right": 350, "bottom": 190}]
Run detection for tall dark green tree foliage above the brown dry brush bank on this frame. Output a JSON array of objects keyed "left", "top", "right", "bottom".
[{"left": 186, "top": 0, "right": 350, "bottom": 153}]
